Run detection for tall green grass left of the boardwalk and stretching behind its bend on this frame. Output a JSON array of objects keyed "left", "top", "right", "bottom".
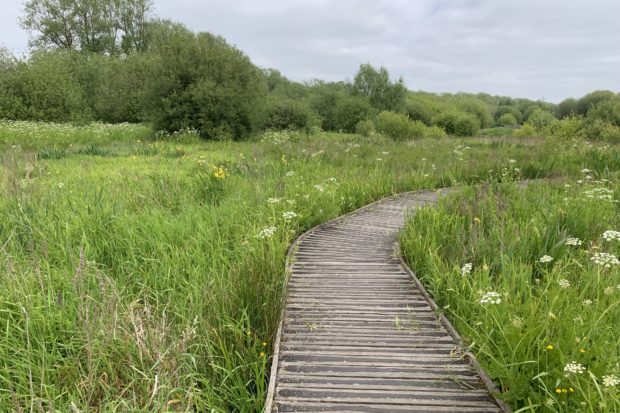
[{"left": 0, "top": 122, "right": 620, "bottom": 412}]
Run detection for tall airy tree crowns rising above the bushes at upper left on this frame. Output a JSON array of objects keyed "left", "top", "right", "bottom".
[{"left": 21, "top": 0, "right": 152, "bottom": 54}]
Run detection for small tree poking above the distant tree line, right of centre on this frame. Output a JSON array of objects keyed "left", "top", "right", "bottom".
[{"left": 353, "top": 64, "right": 407, "bottom": 112}]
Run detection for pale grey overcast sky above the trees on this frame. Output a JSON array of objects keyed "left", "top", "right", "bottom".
[{"left": 0, "top": 0, "right": 620, "bottom": 102}]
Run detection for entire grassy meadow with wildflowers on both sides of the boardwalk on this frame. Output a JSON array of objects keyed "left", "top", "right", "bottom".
[{"left": 0, "top": 121, "right": 620, "bottom": 412}]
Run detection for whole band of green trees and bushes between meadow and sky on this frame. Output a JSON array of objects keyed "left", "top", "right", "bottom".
[{"left": 0, "top": 0, "right": 620, "bottom": 139}]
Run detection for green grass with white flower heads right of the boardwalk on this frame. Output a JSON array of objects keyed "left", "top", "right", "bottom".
[{"left": 401, "top": 179, "right": 620, "bottom": 412}]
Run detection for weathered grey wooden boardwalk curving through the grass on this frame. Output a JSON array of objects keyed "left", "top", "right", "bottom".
[{"left": 265, "top": 191, "right": 509, "bottom": 413}]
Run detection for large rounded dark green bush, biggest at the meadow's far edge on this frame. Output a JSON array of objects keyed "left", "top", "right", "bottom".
[{"left": 146, "top": 22, "right": 265, "bottom": 139}]
